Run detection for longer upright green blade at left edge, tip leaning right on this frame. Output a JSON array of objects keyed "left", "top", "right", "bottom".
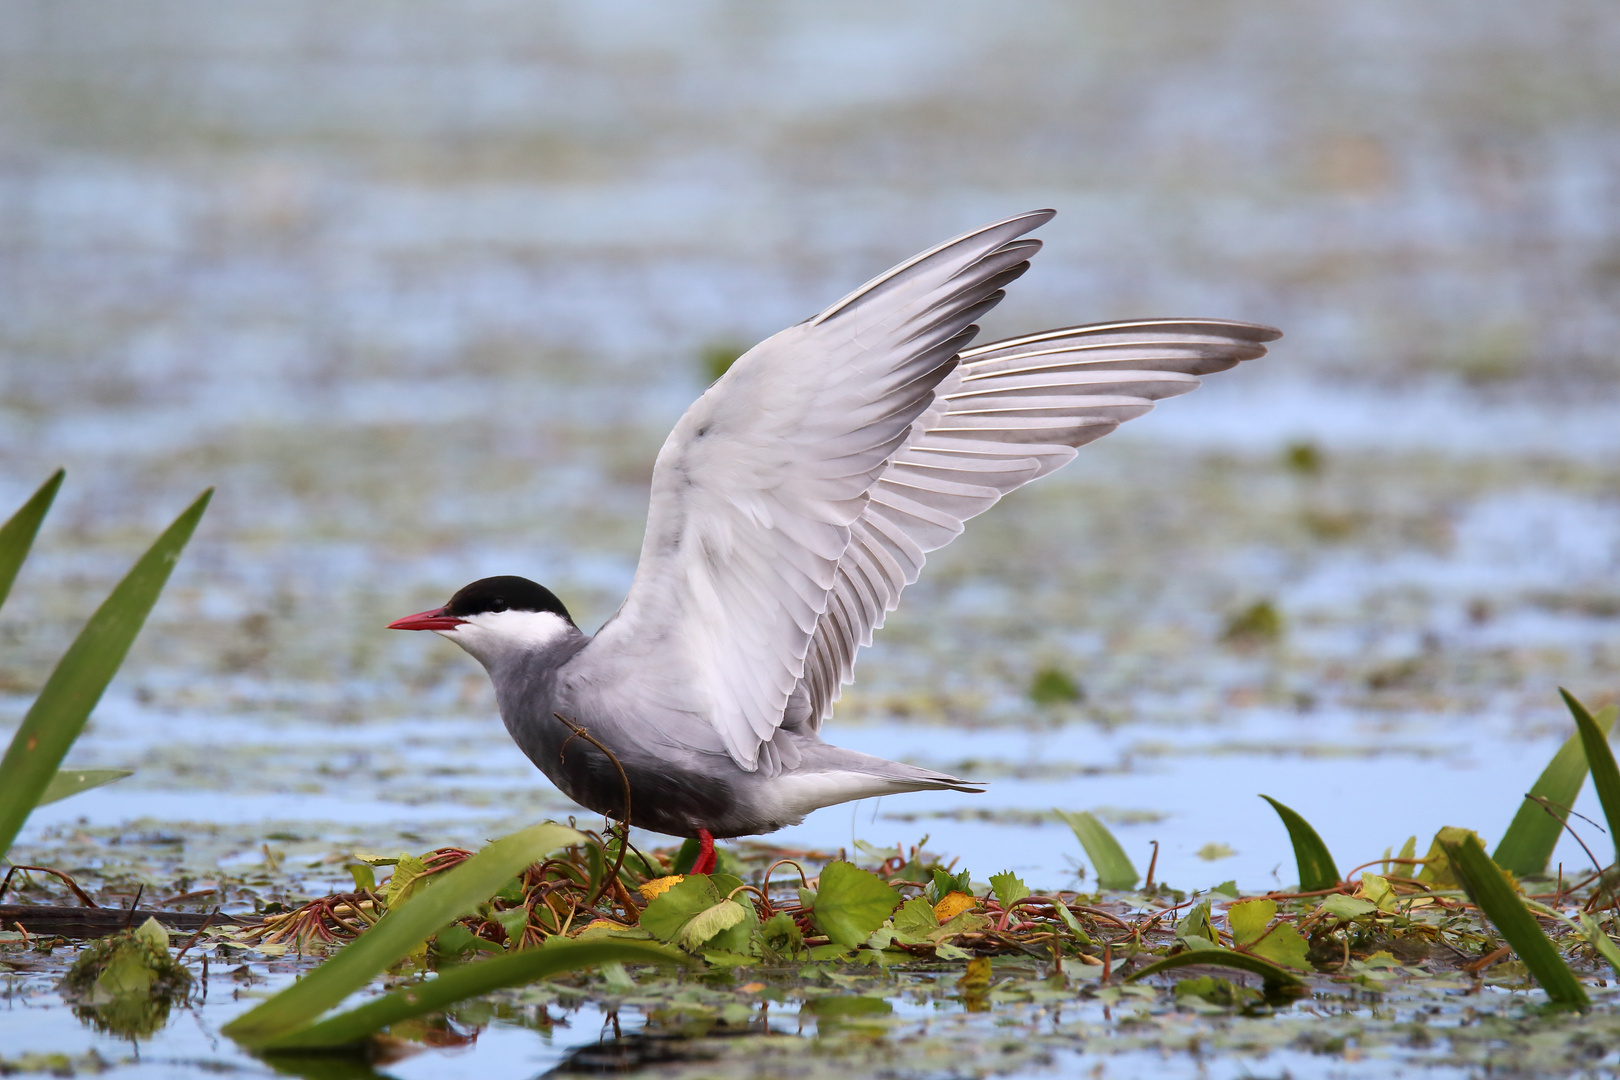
[{"left": 0, "top": 487, "right": 214, "bottom": 855}]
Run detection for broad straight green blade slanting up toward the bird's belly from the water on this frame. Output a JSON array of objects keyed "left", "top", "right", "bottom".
[{"left": 220, "top": 823, "right": 585, "bottom": 1046}]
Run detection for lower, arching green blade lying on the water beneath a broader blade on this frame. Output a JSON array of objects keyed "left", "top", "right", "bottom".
[{"left": 254, "top": 941, "right": 695, "bottom": 1051}]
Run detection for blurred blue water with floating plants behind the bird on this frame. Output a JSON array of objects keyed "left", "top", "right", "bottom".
[{"left": 0, "top": 0, "right": 1620, "bottom": 887}]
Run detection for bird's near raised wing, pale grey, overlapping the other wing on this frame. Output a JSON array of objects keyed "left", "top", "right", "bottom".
[{"left": 593, "top": 210, "right": 1053, "bottom": 771}]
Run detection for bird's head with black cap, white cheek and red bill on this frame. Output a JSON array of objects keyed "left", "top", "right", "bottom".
[{"left": 389, "top": 575, "right": 578, "bottom": 667}]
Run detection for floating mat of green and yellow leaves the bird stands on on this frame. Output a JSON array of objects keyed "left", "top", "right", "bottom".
[{"left": 192, "top": 699, "right": 1620, "bottom": 1048}]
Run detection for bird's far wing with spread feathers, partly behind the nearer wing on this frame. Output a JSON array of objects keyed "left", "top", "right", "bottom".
[{"left": 799, "top": 319, "right": 1281, "bottom": 725}]
